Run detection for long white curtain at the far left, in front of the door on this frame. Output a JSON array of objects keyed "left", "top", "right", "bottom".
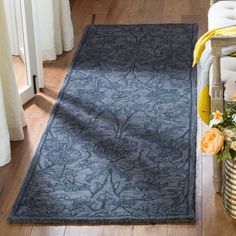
[{"left": 0, "top": 0, "right": 26, "bottom": 166}]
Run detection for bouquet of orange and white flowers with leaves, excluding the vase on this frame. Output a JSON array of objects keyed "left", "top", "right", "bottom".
[{"left": 200, "top": 102, "right": 236, "bottom": 160}]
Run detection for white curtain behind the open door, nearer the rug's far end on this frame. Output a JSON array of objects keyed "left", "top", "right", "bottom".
[{"left": 35, "top": 0, "right": 74, "bottom": 61}]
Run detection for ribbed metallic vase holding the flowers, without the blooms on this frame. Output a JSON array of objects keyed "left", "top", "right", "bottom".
[{"left": 223, "top": 159, "right": 236, "bottom": 219}]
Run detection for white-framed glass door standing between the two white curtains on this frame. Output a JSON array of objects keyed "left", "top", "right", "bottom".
[{"left": 4, "top": 0, "right": 43, "bottom": 104}]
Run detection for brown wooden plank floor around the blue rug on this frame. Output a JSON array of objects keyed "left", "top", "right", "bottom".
[{"left": 0, "top": 0, "right": 236, "bottom": 236}]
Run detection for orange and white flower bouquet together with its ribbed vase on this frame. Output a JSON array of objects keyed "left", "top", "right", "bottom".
[{"left": 201, "top": 101, "right": 236, "bottom": 219}]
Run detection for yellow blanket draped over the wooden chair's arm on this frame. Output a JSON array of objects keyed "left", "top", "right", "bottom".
[{"left": 193, "top": 26, "right": 236, "bottom": 125}]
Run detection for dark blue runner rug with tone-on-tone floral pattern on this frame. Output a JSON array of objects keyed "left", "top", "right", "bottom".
[{"left": 9, "top": 24, "right": 197, "bottom": 224}]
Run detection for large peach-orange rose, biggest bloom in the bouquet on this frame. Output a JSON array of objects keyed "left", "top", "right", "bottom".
[{"left": 201, "top": 128, "right": 225, "bottom": 155}]
